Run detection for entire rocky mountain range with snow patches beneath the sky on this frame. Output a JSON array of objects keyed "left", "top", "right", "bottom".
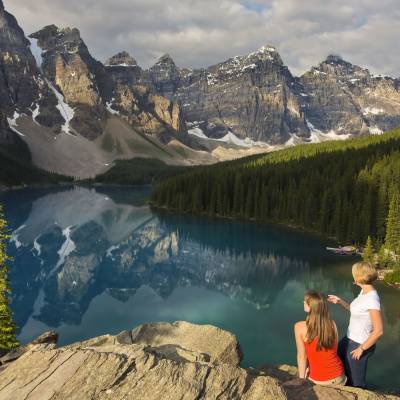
[{"left": 0, "top": 0, "right": 400, "bottom": 178}]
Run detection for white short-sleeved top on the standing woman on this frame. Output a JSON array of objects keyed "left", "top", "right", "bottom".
[{"left": 347, "top": 290, "right": 381, "bottom": 344}]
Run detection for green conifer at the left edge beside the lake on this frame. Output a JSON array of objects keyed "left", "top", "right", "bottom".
[{"left": 0, "top": 206, "right": 19, "bottom": 350}]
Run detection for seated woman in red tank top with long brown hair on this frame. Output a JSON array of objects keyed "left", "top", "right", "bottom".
[{"left": 294, "top": 291, "right": 346, "bottom": 385}]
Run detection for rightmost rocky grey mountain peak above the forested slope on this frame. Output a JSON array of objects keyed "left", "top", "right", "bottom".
[{"left": 299, "top": 55, "right": 400, "bottom": 135}]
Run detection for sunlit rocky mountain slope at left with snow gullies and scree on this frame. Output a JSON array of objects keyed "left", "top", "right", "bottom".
[{"left": 0, "top": 2, "right": 209, "bottom": 178}]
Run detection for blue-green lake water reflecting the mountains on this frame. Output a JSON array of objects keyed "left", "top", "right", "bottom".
[{"left": 0, "top": 187, "right": 400, "bottom": 388}]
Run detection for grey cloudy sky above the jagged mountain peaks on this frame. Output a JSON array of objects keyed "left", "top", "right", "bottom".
[{"left": 4, "top": 0, "right": 400, "bottom": 77}]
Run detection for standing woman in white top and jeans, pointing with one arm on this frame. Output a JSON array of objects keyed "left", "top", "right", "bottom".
[{"left": 328, "top": 262, "right": 383, "bottom": 388}]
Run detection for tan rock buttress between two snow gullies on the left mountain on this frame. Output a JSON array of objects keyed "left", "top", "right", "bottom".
[{"left": 30, "top": 25, "right": 112, "bottom": 139}]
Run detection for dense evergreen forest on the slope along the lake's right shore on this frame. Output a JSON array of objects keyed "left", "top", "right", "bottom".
[{"left": 152, "top": 129, "right": 400, "bottom": 250}]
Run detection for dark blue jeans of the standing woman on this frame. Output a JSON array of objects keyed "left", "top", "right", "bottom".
[{"left": 338, "top": 336, "right": 376, "bottom": 388}]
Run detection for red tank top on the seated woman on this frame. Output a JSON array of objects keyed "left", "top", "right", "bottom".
[{"left": 304, "top": 337, "right": 344, "bottom": 381}]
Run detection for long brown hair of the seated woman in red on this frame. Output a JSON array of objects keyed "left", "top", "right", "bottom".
[{"left": 304, "top": 290, "right": 336, "bottom": 350}]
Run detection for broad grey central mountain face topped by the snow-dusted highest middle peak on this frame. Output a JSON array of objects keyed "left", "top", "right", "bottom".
[{"left": 144, "top": 45, "right": 309, "bottom": 144}]
